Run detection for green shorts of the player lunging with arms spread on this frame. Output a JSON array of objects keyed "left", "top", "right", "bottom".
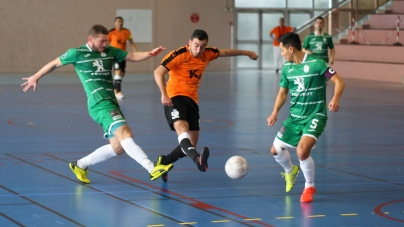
[{"left": 89, "top": 100, "right": 126, "bottom": 138}]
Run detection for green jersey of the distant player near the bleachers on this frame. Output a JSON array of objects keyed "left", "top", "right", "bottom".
[{"left": 303, "top": 32, "right": 334, "bottom": 63}]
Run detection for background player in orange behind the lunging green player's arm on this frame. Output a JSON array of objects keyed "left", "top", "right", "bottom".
[{"left": 108, "top": 17, "right": 137, "bottom": 99}]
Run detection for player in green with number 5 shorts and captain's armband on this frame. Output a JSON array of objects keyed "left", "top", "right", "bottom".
[{"left": 267, "top": 32, "right": 345, "bottom": 202}]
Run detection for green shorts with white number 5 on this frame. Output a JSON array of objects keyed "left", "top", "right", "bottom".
[{"left": 276, "top": 115, "right": 328, "bottom": 147}]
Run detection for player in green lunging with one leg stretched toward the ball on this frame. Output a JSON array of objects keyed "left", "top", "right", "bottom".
[{"left": 21, "top": 25, "right": 173, "bottom": 183}]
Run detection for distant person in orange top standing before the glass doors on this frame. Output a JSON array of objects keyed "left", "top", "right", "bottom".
[{"left": 269, "top": 17, "right": 294, "bottom": 73}]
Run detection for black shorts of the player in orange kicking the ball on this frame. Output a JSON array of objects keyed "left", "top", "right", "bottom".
[{"left": 164, "top": 96, "right": 199, "bottom": 131}]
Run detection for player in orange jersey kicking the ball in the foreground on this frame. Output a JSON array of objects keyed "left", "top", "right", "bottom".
[{"left": 154, "top": 29, "right": 258, "bottom": 181}]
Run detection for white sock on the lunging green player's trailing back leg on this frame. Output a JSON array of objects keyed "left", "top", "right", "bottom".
[{"left": 77, "top": 144, "right": 117, "bottom": 169}]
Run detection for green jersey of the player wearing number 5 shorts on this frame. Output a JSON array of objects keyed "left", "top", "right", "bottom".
[{"left": 279, "top": 54, "right": 336, "bottom": 123}]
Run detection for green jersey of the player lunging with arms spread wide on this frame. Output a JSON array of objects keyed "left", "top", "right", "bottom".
[{"left": 59, "top": 45, "right": 128, "bottom": 109}]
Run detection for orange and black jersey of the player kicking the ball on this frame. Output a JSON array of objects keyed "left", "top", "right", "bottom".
[{"left": 161, "top": 45, "right": 219, "bottom": 103}]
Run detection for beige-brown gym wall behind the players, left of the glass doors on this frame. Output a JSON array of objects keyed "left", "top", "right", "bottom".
[{"left": 0, "top": 0, "right": 233, "bottom": 73}]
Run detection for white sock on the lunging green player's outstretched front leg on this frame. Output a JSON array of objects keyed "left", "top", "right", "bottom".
[{"left": 121, "top": 138, "right": 154, "bottom": 173}]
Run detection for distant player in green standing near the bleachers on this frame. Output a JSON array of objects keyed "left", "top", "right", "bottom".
[{"left": 303, "top": 17, "right": 335, "bottom": 65}]
